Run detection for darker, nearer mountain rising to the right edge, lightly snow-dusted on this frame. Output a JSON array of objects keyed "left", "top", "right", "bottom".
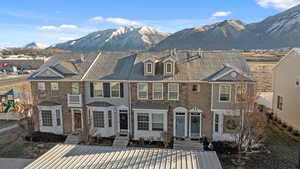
[{"left": 151, "top": 5, "right": 300, "bottom": 50}]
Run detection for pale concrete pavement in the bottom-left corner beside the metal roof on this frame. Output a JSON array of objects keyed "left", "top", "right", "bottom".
[{"left": 0, "top": 158, "right": 33, "bottom": 169}]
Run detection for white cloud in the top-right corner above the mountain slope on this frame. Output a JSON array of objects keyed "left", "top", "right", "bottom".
[{"left": 257, "top": 0, "right": 300, "bottom": 9}]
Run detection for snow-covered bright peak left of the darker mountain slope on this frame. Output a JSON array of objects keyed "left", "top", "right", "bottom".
[{"left": 50, "top": 26, "right": 169, "bottom": 52}]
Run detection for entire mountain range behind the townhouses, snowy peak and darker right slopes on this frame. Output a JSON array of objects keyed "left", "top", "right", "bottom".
[{"left": 50, "top": 5, "right": 300, "bottom": 51}]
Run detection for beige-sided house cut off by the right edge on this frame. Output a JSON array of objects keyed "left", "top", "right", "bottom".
[{"left": 273, "top": 48, "right": 300, "bottom": 131}]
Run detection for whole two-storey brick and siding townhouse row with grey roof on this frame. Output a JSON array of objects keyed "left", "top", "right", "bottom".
[{"left": 29, "top": 50, "right": 255, "bottom": 141}]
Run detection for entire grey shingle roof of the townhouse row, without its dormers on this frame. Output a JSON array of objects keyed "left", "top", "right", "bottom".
[{"left": 29, "top": 50, "right": 250, "bottom": 82}]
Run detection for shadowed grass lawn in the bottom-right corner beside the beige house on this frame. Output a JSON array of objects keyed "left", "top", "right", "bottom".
[{"left": 219, "top": 124, "right": 300, "bottom": 169}]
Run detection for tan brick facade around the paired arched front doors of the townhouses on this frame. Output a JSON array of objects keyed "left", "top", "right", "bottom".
[{"left": 130, "top": 83, "right": 213, "bottom": 138}]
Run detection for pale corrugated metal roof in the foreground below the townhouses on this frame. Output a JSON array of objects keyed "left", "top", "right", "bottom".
[{"left": 25, "top": 144, "right": 222, "bottom": 169}]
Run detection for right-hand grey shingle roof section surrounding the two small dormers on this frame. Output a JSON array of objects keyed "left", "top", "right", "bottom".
[{"left": 129, "top": 50, "right": 250, "bottom": 81}]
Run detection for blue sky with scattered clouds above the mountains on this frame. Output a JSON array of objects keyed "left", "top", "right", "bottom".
[{"left": 0, "top": 0, "right": 300, "bottom": 47}]
